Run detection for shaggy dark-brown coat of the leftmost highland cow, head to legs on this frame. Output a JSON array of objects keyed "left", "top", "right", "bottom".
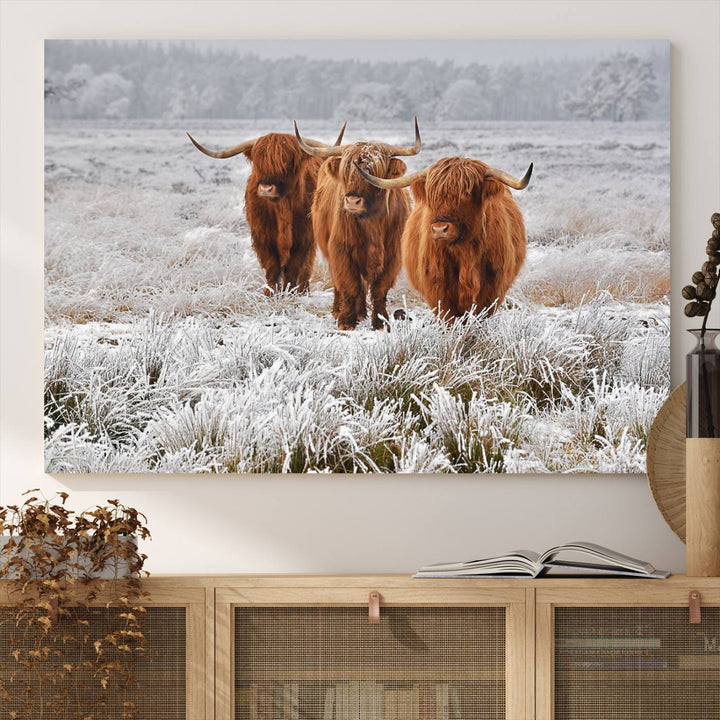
[{"left": 244, "top": 133, "right": 322, "bottom": 292}]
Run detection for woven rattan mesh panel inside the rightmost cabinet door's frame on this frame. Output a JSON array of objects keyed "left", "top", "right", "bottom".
[{"left": 554, "top": 607, "right": 720, "bottom": 720}]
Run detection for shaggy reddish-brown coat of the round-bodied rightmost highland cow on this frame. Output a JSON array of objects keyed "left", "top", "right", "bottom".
[{"left": 402, "top": 157, "right": 526, "bottom": 317}]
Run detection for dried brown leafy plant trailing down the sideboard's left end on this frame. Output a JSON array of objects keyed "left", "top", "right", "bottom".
[{"left": 0, "top": 490, "right": 150, "bottom": 720}]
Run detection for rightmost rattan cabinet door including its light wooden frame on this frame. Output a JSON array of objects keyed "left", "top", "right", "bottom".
[{"left": 536, "top": 579, "right": 720, "bottom": 720}]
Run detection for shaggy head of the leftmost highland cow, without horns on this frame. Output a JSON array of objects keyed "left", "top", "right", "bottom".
[{"left": 245, "top": 133, "right": 308, "bottom": 202}]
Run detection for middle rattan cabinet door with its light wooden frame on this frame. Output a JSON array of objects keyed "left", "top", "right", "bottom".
[{"left": 216, "top": 592, "right": 527, "bottom": 720}]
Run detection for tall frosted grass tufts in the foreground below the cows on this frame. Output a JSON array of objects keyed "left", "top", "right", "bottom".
[{"left": 45, "top": 302, "right": 668, "bottom": 472}]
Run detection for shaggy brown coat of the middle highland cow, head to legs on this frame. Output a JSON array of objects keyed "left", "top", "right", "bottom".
[{"left": 312, "top": 142, "right": 410, "bottom": 330}]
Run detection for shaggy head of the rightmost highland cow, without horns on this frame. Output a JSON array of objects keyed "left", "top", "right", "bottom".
[{"left": 412, "top": 158, "right": 502, "bottom": 245}]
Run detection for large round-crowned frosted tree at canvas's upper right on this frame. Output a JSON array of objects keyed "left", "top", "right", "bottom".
[{"left": 563, "top": 53, "right": 658, "bottom": 122}]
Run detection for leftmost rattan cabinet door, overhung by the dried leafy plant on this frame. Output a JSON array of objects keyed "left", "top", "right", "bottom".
[{"left": 0, "top": 582, "right": 211, "bottom": 720}]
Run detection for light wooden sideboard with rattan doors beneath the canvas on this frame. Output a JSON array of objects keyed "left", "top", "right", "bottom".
[{"left": 0, "top": 575, "right": 720, "bottom": 720}]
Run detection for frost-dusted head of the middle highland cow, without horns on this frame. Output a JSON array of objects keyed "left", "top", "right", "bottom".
[{"left": 325, "top": 142, "right": 407, "bottom": 218}]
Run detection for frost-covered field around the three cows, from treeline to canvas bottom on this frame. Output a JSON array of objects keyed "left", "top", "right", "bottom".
[{"left": 45, "top": 119, "right": 670, "bottom": 473}]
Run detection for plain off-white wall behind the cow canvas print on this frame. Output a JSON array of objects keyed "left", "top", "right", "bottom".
[{"left": 0, "top": 0, "right": 720, "bottom": 573}]
